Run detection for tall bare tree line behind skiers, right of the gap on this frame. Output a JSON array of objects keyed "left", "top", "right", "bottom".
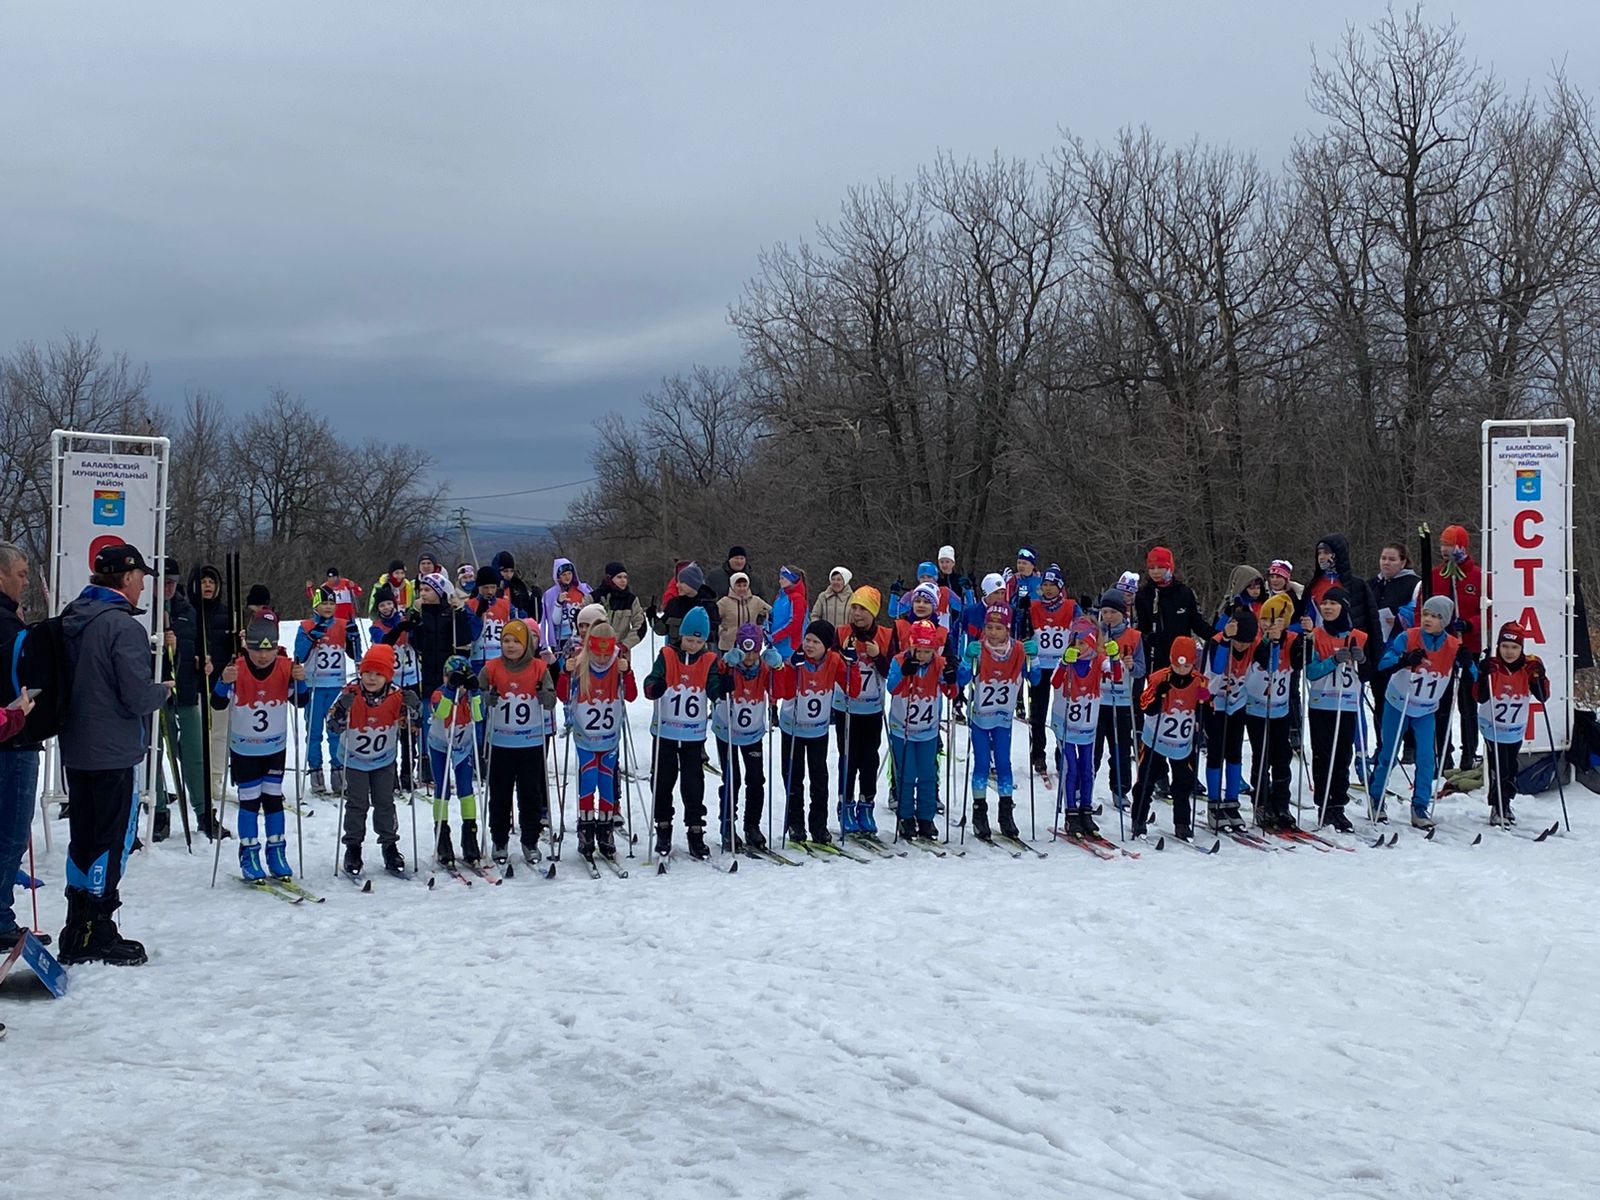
[{"left": 555, "top": 10, "right": 1600, "bottom": 611}]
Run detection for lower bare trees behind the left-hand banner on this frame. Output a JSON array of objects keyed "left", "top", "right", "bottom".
[{"left": 0, "top": 334, "right": 443, "bottom": 616}]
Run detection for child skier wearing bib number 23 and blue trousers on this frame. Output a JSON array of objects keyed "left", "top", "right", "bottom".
[{"left": 955, "top": 602, "right": 1038, "bottom": 842}]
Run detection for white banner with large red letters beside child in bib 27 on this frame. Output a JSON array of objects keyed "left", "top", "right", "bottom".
[{"left": 1483, "top": 435, "right": 1573, "bottom": 749}]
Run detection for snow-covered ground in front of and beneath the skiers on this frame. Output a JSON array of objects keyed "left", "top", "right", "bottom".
[{"left": 0, "top": 649, "right": 1600, "bottom": 1200}]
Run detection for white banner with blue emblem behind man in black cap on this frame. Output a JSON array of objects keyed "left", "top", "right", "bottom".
[{"left": 54, "top": 450, "right": 162, "bottom": 640}]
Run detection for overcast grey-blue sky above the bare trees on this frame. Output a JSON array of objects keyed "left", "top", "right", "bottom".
[{"left": 0, "top": 0, "right": 1600, "bottom": 522}]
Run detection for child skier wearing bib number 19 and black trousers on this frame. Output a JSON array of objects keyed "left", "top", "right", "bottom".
[{"left": 478, "top": 620, "right": 555, "bottom": 866}]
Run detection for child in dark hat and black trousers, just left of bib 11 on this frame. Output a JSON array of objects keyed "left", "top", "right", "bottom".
[{"left": 1306, "top": 587, "right": 1366, "bottom": 834}]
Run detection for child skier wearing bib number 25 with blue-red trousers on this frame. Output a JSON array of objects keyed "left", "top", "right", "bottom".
[{"left": 555, "top": 621, "right": 640, "bottom": 862}]
